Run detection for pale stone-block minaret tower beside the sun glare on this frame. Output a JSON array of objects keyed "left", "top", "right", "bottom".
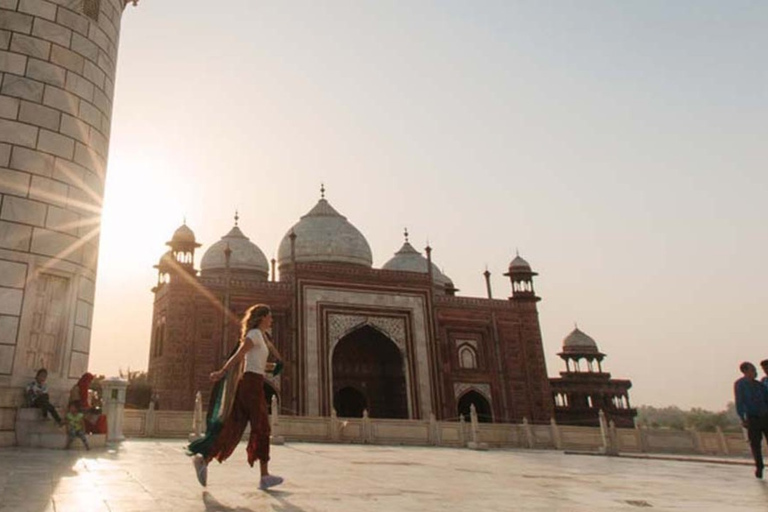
[{"left": 0, "top": 0, "right": 136, "bottom": 396}]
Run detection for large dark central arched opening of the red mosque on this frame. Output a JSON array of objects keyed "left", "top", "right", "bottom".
[{"left": 331, "top": 325, "right": 408, "bottom": 418}]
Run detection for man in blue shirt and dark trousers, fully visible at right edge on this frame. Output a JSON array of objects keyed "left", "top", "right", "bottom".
[{"left": 733, "top": 362, "right": 768, "bottom": 478}]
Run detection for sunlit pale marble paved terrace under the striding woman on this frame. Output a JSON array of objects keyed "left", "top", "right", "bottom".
[{"left": 0, "top": 440, "right": 768, "bottom": 512}]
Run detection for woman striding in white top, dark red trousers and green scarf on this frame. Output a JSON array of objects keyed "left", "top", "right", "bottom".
[{"left": 188, "top": 304, "right": 283, "bottom": 489}]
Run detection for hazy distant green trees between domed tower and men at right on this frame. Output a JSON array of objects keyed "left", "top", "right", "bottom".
[{"left": 635, "top": 402, "right": 741, "bottom": 432}]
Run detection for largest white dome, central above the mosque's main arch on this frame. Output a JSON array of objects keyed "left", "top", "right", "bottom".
[{"left": 277, "top": 198, "right": 373, "bottom": 267}]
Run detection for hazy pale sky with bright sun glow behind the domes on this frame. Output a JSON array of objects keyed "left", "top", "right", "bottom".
[{"left": 91, "top": 0, "right": 768, "bottom": 409}]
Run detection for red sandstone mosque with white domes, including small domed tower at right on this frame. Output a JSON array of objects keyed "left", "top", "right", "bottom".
[{"left": 149, "top": 192, "right": 635, "bottom": 426}]
